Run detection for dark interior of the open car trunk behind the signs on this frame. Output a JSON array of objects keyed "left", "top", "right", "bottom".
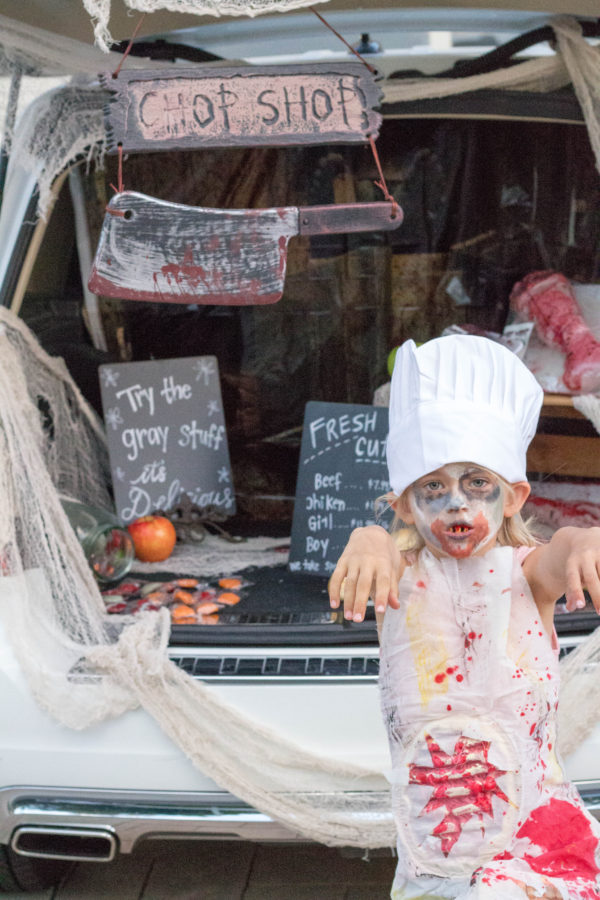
[{"left": 4, "top": 89, "right": 600, "bottom": 656}]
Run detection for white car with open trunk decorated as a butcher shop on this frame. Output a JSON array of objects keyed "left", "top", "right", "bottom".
[{"left": 0, "top": 3, "right": 600, "bottom": 892}]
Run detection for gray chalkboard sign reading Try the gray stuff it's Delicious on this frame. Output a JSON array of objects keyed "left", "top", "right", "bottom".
[{"left": 99, "top": 356, "right": 235, "bottom": 523}]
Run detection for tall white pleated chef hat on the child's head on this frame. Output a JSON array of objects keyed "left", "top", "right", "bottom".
[{"left": 387, "top": 334, "right": 543, "bottom": 495}]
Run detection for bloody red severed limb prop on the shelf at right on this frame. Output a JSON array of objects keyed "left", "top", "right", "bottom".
[{"left": 510, "top": 271, "right": 600, "bottom": 393}]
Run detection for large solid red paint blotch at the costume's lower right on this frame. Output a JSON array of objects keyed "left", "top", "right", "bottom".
[{"left": 517, "top": 798, "right": 600, "bottom": 880}]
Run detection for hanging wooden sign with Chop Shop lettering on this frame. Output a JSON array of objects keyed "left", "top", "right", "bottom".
[{"left": 101, "top": 62, "right": 381, "bottom": 152}]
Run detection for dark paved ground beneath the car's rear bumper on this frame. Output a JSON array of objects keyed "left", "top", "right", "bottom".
[{"left": 7, "top": 840, "right": 395, "bottom": 900}]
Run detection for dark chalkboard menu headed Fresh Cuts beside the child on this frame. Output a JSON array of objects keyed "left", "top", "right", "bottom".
[{"left": 289, "top": 402, "right": 392, "bottom": 575}]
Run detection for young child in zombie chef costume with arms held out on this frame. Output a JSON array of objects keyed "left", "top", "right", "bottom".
[{"left": 330, "top": 335, "right": 600, "bottom": 900}]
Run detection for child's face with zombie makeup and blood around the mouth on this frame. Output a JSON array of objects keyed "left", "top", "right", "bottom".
[{"left": 403, "top": 463, "right": 507, "bottom": 559}]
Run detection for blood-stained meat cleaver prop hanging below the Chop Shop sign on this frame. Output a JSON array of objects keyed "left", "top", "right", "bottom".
[{"left": 88, "top": 191, "right": 403, "bottom": 306}]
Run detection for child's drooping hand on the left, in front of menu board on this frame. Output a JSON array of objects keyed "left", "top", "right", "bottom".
[{"left": 329, "top": 525, "right": 406, "bottom": 622}]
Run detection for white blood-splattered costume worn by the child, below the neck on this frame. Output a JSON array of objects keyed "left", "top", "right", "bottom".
[{"left": 380, "top": 547, "right": 600, "bottom": 900}]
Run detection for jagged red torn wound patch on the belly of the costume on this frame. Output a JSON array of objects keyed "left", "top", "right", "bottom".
[{"left": 408, "top": 734, "right": 509, "bottom": 856}]
